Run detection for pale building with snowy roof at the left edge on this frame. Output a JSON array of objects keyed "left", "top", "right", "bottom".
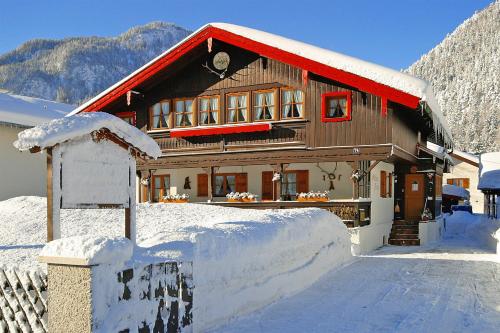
[{"left": 0, "top": 92, "right": 74, "bottom": 200}]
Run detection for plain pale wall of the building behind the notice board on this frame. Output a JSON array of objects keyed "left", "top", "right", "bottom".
[{"left": 0, "top": 126, "right": 47, "bottom": 200}]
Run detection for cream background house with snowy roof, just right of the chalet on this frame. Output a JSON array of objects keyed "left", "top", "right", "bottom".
[{"left": 443, "top": 150, "right": 484, "bottom": 214}]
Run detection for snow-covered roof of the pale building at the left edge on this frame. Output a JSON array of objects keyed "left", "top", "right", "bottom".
[{"left": 0, "top": 92, "right": 75, "bottom": 127}]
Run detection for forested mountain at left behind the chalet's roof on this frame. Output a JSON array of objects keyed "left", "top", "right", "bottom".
[{"left": 0, "top": 22, "right": 191, "bottom": 104}]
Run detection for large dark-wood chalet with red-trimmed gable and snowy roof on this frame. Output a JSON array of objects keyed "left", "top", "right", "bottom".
[{"left": 72, "top": 23, "right": 452, "bottom": 248}]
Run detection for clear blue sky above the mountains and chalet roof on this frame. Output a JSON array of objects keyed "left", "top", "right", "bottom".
[{"left": 0, "top": 0, "right": 493, "bottom": 69}]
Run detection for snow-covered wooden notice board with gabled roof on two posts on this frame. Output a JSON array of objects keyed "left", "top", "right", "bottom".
[{"left": 14, "top": 112, "right": 161, "bottom": 241}]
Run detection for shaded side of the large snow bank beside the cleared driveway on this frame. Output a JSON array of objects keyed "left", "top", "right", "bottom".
[{"left": 193, "top": 209, "right": 351, "bottom": 332}]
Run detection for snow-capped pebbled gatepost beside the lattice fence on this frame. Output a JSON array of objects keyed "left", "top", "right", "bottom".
[{"left": 39, "top": 236, "right": 134, "bottom": 332}]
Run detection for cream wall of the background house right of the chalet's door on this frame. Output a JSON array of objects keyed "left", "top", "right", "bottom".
[{"left": 443, "top": 159, "right": 484, "bottom": 214}]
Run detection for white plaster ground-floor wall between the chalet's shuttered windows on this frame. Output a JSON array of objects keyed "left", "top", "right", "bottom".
[{"left": 153, "top": 162, "right": 352, "bottom": 202}]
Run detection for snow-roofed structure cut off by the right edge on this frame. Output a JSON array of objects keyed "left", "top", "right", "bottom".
[{"left": 477, "top": 152, "right": 500, "bottom": 218}]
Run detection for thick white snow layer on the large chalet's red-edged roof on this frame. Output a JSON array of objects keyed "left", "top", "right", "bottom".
[{"left": 64, "top": 23, "right": 451, "bottom": 138}]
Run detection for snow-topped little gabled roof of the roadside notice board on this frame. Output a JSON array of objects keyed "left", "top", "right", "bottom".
[{"left": 14, "top": 112, "right": 161, "bottom": 158}]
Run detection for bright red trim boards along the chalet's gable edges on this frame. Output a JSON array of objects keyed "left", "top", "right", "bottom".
[{"left": 82, "top": 26, "right": 420, "bottom": 112}]
